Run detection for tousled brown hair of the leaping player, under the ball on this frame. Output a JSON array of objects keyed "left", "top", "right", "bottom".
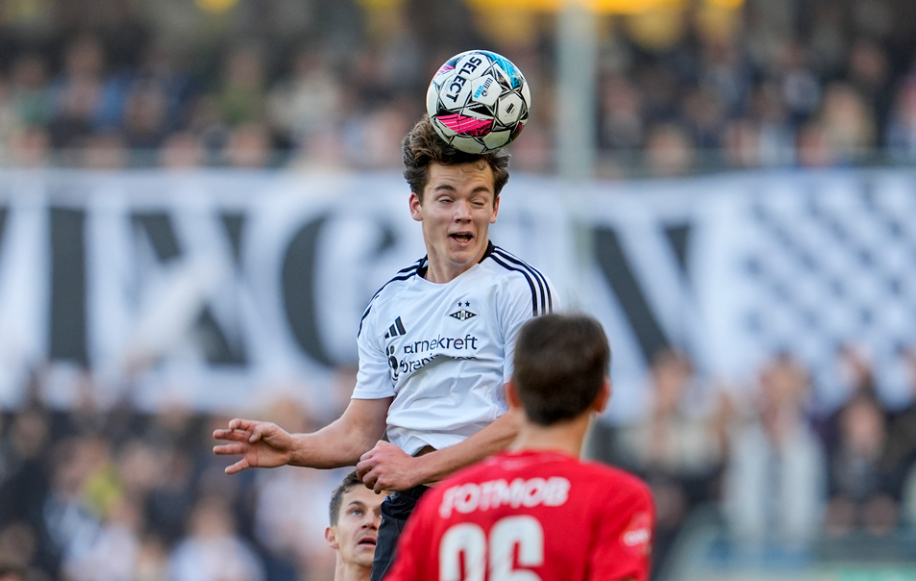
[{"left": 401, "top": 114, "right": 509, "bottom": 203}]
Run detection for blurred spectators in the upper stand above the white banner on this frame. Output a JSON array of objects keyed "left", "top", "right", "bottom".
[{"left": 0, "top": 0, "right": 916, "bottom": 177}]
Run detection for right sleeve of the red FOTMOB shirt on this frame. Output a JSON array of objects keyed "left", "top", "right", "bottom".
[{"left": 589, "top": 483, "right": 655, "bottom": 581}]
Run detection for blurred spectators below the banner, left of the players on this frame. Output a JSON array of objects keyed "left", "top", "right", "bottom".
[{"left": 0, "top": 368, "right": 347, "bottom": 581}]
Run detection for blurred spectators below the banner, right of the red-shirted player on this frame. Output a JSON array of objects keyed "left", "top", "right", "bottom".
[{"left": 597, "top": 344, "right": 916, "bottom": 568}]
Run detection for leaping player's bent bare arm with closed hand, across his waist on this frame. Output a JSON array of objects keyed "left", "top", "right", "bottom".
[{"left": 356, "top": 410, "right": 521, "bottom": 492}]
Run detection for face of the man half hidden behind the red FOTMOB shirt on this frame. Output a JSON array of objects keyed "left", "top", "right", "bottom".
[{"left": 325, "top": 485, "right": 385, "bottom": 567}]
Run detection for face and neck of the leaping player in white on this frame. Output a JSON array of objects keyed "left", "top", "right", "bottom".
[{"left": 410, "top": 162, "right": 499, "bottom": 283}]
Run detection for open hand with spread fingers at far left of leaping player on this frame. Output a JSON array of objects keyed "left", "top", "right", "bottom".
[{"left": 213, "top": 418, "right": 294, "bottom": 474}]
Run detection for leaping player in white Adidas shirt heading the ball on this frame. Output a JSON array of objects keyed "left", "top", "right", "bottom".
[{"left": 213, "top": 87, "right": 558, "bottom": 581}]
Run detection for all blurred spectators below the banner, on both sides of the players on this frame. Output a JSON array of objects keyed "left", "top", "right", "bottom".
[{"left": 0, "top": 345, "right": 916, "bottom": 581}]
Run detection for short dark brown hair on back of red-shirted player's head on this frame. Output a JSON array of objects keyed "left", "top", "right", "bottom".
[{"left": 513, "top": 314, "right": 611, "bottom": 426}]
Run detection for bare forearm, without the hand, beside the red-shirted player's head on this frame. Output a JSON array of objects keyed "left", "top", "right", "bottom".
[{"left": 417, "top": 410, "right": 521, "bottom": 483}]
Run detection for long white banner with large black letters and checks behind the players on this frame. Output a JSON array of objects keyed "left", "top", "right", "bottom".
[{"left": 0, "top": 170, "right": 916, "bottom": 417}]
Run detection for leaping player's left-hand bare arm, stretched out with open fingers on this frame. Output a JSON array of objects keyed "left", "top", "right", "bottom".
[{"left": 213, "top": 397, "right": 392, "bottom": 474}]
